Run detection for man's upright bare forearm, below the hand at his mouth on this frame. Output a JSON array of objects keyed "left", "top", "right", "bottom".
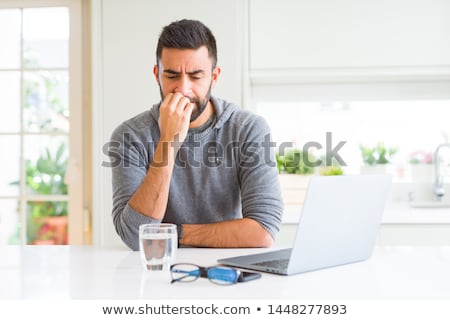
[{"left": 129, "top": 141, "right": 176, "bottom": 220}]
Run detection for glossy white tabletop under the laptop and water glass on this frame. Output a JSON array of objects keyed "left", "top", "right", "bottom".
[{"left": 0, "top": 246, "right": 450, "bottom": 299}]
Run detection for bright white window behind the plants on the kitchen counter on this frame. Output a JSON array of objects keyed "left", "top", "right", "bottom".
[{"left": 256, "top": 99, "right": 450, "bottom": 180}]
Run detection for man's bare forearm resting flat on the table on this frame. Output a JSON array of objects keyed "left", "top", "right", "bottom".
[{"left": 180, "top": 218, "right": 273, "bottom": 248}]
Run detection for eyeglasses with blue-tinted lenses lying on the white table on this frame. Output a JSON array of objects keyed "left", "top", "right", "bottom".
[{"left": 170, "top": 263, "right": 241, "bottom": 285}]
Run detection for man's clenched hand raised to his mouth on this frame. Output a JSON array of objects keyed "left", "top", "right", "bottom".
[{"left": 158, "top": 92, "right": 195, "bottom": 143}]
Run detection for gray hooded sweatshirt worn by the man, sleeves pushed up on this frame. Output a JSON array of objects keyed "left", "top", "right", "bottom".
[{"left": 108, "top": 97, "right": 283, "bottom": 250}]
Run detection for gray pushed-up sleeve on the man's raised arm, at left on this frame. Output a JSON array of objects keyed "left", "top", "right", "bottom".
[{"left": 108, "top": 123, "right": 160, "bottom": 250}]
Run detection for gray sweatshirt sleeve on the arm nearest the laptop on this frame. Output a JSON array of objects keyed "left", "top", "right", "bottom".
[{"left": 239, "top": 115, "right": 283, "bottom": 238}]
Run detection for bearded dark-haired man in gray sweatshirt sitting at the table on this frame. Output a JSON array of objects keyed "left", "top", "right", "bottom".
[{"left": 110, "top": 20, "right": 283, "bottom": 250}]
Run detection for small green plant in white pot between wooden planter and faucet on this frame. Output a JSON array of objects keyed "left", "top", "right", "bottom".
[{"left": 359, "top": 142, "right": 397, "bottom": 174}]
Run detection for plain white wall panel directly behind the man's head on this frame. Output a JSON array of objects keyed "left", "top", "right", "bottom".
[{"left": 93, "top": 0, "right": 245, "bottom": 245}]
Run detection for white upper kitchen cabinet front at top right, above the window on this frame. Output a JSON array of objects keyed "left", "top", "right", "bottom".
[{"left": 250, "top": 0, "right": 450, "bottom": 70}]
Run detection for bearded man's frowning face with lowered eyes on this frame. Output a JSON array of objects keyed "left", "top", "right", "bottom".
[{"left": 153, "top": 46, "right": 220, "bottom": 122}]
